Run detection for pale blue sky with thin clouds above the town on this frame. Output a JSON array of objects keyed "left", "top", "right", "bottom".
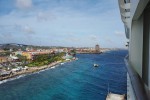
[{"left": 0, "top": 0, "right": 126, "bottom": 48}]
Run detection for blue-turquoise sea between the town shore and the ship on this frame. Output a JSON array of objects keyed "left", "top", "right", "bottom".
[{"left": 0, "top": 50, "right": 127, "bottom": 100}]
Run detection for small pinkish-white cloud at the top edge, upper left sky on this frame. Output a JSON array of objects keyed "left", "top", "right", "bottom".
[{"left": 16, "top": 0, "right": 32, "bottom": 9}]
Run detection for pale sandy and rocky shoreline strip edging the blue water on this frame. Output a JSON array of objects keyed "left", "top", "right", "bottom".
[{"left": 0, "top": 60, "right": 73, "bottom": 84}]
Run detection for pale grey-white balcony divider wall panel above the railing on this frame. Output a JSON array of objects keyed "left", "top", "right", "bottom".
[{"left": 129, "top": 16, "right": 143, "bottom": 77}]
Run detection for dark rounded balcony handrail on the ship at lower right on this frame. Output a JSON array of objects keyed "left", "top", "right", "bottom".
[{"left": 125, "top": 56, "right": 150, "bottom": 100}]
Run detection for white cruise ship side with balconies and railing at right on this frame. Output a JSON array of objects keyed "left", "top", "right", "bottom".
[{"left": 118, "top": 0, "right": 150, "bottom": 100}]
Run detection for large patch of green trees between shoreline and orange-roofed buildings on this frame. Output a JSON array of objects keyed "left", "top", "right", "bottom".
[{"left": 28, "top": 53, "right": 64, "bottom": 67}]
